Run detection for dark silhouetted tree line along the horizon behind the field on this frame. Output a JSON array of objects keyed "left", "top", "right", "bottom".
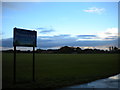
[{"left": 2, "top": 46, "right": 120, "bottom": 54}]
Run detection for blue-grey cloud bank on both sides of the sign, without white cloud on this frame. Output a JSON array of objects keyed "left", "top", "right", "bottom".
[{"left": 2, "top": 35, "right": 120, "bottom": 48}]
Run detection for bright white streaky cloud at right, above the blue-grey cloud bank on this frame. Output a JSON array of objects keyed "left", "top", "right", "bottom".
[{"left": 77, "top": 28, "right": 118, "bottom": 41}]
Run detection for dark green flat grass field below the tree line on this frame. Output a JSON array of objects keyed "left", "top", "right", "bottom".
[{"left": 2, "top": 53, "right": 120, "bottom": 88}]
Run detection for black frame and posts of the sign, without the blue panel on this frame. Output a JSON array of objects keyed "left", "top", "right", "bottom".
[{"left": 13, "top": 27, "right": 37, "bottom": 84}]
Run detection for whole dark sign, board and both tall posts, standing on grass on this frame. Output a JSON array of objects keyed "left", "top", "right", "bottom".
[{"left": 13, "top": 28, "right": 37, "bottom": 83}]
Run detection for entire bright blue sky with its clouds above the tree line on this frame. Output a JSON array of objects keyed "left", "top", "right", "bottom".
[{"left": 0, "top": 2, "right": 118, "bottom": 49}]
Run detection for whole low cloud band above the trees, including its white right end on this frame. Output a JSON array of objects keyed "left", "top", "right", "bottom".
[{"left": 1, "top": 28, "right": 120, "bottom": 49}]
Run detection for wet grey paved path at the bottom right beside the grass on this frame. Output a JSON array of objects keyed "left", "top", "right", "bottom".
[{"left": 67, "top": 74, "right": 120, "bottom": 88}]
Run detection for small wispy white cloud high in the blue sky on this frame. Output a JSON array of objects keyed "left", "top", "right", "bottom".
[{"left": 83, "top": 7, "right": 105, "bottom": 14}]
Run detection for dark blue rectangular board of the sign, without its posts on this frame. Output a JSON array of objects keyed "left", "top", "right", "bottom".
[{"left": 13, "top": 28, "right": 37, "bottom": 47}]
